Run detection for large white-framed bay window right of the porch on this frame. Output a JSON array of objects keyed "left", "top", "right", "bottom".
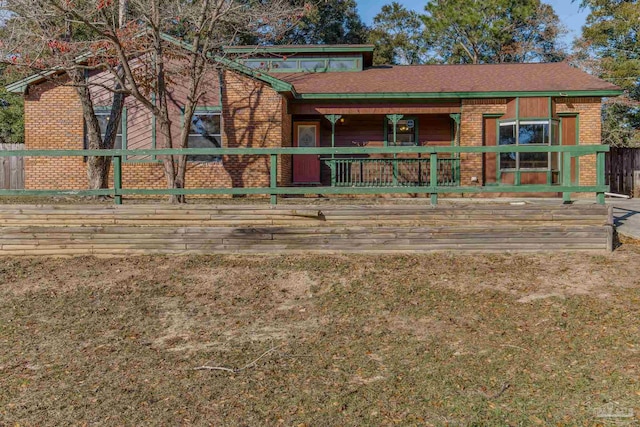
[{"left": 498, "top": 120, "right": 558, "bottom": 169}]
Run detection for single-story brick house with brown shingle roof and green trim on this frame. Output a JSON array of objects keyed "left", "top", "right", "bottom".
[{"left": 8, "top": 45, "right": 621, "bottom": 196}]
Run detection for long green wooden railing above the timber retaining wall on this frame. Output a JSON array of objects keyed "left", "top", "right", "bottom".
[{"left": 0, "top": 145, "right": 609, "bottom": 204}]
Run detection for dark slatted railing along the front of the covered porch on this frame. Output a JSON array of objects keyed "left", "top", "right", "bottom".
[{"left": 323, "top": 157, "right": 460, "bottom": 187}]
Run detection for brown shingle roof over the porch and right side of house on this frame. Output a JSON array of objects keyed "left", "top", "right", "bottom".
[{"left": 273, "top": 62, "right": 620, "bottom": 94}]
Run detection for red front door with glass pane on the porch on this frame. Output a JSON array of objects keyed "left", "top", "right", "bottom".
[{"left": 293, "top": 122, "right": 320, "bottom": 184}]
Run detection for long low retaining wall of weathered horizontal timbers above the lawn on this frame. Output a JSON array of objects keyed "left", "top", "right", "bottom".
[{"left": 0, "top": 203, "right": 613, "bottom": 256}]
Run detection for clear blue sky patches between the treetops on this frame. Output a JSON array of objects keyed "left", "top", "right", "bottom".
[{"left": 357, "top": 0, "right": 588, "bottom": 44}]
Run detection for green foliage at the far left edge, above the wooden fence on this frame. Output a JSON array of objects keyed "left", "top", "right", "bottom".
[{"left": 0, "top": 66, "right": 24, "bottom": 144}]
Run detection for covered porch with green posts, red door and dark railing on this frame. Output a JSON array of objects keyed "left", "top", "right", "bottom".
[{"left": 292, "top": 101, "right": 460, "bottom": 187}]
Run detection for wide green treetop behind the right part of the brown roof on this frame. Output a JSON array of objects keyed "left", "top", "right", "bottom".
[{"left": 423, "top": 0, "right": 564, "bottom": 64}]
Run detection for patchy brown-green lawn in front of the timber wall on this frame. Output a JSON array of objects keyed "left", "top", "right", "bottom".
[{"left": 0, "top": 246, "right": 640, "bottom": 426}]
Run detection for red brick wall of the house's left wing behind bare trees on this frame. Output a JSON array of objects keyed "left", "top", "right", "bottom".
[{"left": 25, "top": 72, "right": 291, "bottom": 194}]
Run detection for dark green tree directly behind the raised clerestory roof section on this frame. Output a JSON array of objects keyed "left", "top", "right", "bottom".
[{"left": 281, "top": 0, "right": 368, "bottom": 44}]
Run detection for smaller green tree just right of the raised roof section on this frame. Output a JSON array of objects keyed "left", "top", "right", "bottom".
[{"left": 369, "top": 2, "right": 426, "bottom": 65}]
